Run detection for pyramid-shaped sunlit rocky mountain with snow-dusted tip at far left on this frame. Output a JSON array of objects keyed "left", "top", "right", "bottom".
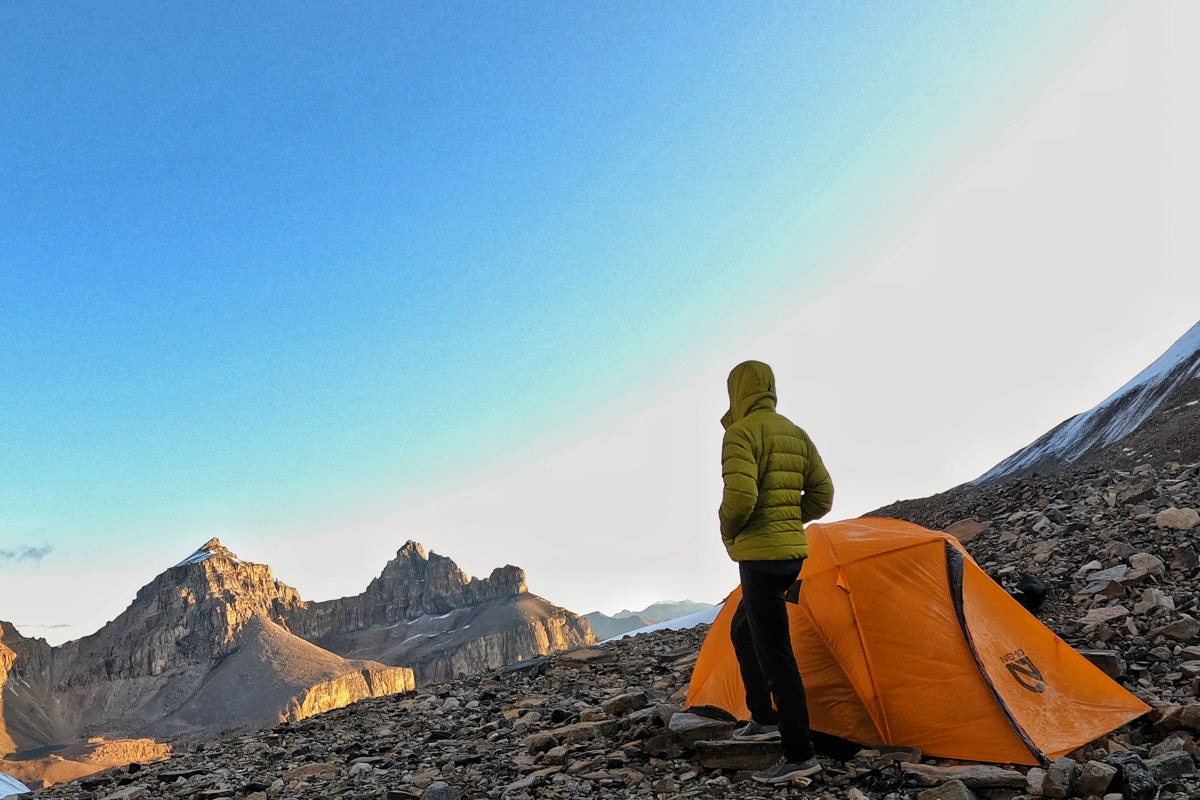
[{"left": 0, "top": 539, "right": 414, "bottom": 777}]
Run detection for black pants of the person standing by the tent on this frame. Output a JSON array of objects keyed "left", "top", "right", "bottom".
[{"left": 730, "top": 564, "right": 812, "bottom": 762}]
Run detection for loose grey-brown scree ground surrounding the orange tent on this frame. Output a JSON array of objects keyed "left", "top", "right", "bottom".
[{"left": 18, "top": 464, "right": 1200, "bottom": 800}]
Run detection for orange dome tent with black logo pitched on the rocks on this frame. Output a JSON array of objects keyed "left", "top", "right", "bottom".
[{"left": 688, "top": 517, "right": 1150, "bottom": 764}]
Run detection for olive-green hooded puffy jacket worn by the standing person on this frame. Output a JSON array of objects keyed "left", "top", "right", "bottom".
[{"left": 720, "top": 361, "right": 833, "bottom": 561}]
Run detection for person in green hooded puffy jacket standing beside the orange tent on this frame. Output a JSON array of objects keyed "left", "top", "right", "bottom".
[{"left": 719, "top": 361, "right": 833, "bottom": 783}]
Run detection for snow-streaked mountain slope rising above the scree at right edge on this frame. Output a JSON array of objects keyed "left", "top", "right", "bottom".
[{"left": 973, "top": 323, "right": 1200, "bottom": 483}]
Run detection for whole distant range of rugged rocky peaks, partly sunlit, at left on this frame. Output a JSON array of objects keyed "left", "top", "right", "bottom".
[{"left": 0, "top": 539, "right": 595, "bottom": 780}]
